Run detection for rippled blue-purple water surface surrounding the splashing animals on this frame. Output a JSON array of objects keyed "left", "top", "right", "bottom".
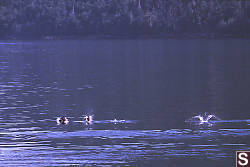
[{"left": 0, "top": 40, "right": 250, "bottom": 167}]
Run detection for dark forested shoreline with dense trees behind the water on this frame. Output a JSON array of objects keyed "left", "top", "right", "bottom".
[{"left": 0, "top": 0, "right": 250, "bottom": 39}]
